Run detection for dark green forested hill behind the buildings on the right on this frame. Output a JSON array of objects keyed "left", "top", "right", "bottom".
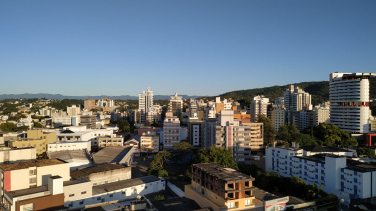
[{"left": 220, "top": 77, "right": 376, "bottom": 110}]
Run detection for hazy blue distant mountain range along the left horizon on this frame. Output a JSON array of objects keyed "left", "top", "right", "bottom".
[{"left": 0, "top": 93, "right": 205, "bottom": 100}]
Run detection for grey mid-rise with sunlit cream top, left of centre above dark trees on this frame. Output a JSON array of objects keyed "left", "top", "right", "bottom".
[{"left": 163, "top": 112, "right": 180, "bottom": 150}]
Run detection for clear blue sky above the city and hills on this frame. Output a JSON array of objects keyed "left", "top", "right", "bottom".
[{"left": 0, "top": 0, "right": 376, "bottom": 96}]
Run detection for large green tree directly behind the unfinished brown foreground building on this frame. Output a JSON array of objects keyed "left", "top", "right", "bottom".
[{"left": 194, "top": 146, "right": 239, "bottom": 170}]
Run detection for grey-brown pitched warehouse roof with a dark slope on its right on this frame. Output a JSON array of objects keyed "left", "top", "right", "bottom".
[{"left": 93, "top": 147, "right": 132, "bottom": 164}]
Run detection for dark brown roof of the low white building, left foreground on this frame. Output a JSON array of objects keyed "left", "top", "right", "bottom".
[{"left": 70, "top": 163, "right": 131, "bottom": 179}]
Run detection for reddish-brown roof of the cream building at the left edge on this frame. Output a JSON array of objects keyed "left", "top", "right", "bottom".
[{"left": 0, "top": 159, "right": 66, "bottom": 171}]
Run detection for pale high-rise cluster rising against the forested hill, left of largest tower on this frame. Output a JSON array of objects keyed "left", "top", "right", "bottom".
[{"left": 283, "top": 85, "right": 311, "bottom": 111}]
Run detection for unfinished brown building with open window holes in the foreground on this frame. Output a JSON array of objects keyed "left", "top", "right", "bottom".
[{"left": 185, "top": 163, "right": 256, "bottom": 211}]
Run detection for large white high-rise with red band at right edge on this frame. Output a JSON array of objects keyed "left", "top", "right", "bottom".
[{"left": 329, "top": 73, "right": 376, "bottom": 133}]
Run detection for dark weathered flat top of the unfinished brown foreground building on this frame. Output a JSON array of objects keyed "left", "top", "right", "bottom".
[{"left": 193, "top": 163, "right": 255, "bottom": 182}]
